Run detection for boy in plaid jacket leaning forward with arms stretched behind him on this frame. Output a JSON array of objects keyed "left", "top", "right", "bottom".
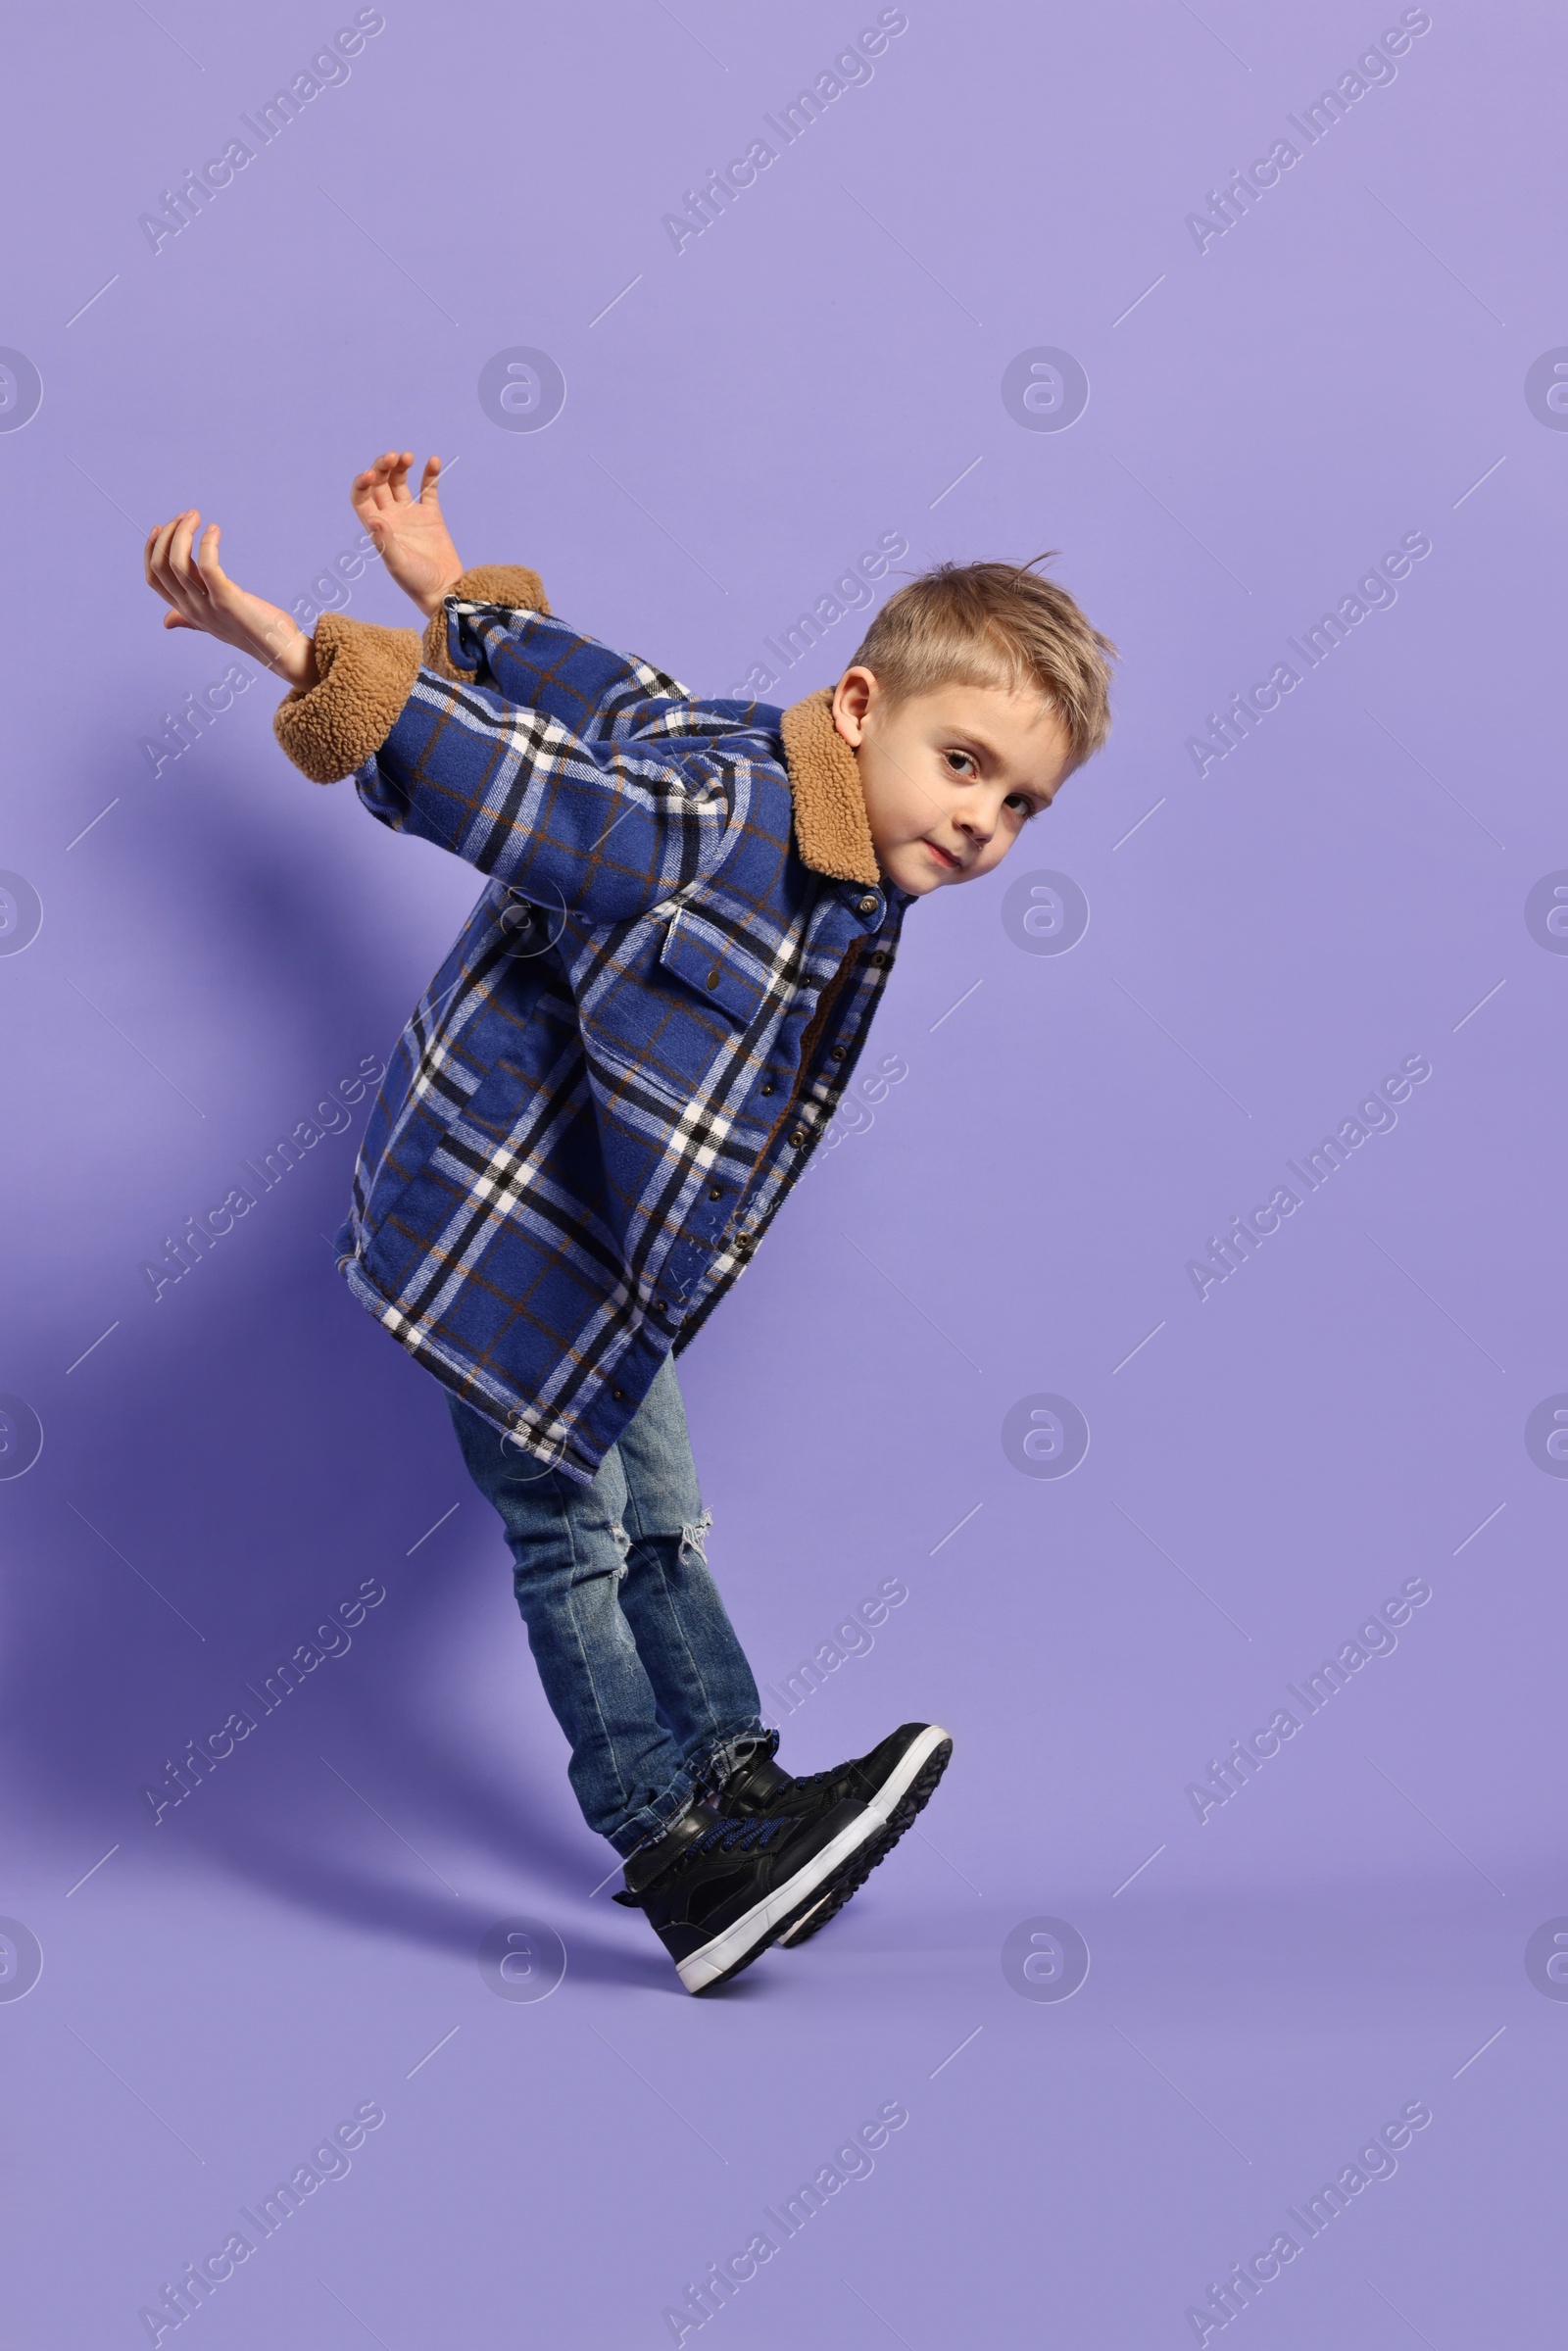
[{"left": 146, "top": 452, "right": 1114, "bottom": 1991}]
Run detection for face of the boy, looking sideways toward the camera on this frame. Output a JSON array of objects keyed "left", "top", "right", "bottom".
[{"left": 832, "top": 667, "right": 1069, "bottom": 898}]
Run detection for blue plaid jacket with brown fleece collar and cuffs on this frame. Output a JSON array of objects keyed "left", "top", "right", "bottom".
[{"left": 275, "top": 564, "right": 912, "bottom": 1484}]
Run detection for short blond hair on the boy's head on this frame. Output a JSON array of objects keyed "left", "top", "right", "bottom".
[{"left": 851, "top": 550, "right": 1116, "bottom": 766}]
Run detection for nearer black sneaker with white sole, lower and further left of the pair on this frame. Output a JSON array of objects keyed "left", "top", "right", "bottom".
[{"left": 615, "top": 1796, "right": 884, "bottom": 1991}]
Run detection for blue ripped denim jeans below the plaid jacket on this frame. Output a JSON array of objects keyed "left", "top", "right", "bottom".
[{"left": 447, "top": 1356, "right": 778, "bottom": 1857}]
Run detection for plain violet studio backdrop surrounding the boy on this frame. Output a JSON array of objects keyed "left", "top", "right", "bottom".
[{"left": 0, "top": 0, "right": 1568, "bottom": 2351}]
